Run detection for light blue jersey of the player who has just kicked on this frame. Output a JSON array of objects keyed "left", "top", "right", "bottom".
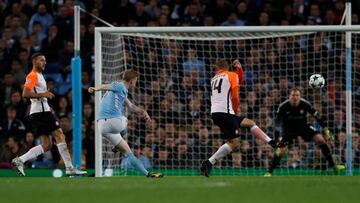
[{"left": 97, "top": 82, "right": 128, "bottom": 120}]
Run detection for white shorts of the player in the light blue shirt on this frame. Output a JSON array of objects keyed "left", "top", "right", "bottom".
[{"left": 98, "top": 116, "right": 127, "bottom": 146}]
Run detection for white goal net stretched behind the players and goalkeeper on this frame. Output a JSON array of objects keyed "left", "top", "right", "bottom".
[{"left": 95, "top": 28, "right": 360, "bottom": 176}]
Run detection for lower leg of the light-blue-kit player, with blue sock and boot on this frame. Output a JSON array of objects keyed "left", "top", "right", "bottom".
[{"left": 115, "top": 139, "right": 164, "bottom": 178}]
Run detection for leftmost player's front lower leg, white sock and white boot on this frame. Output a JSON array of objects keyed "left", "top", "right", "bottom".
[{"left": 51, "top": 128, "right": 87, "bottom": 177}]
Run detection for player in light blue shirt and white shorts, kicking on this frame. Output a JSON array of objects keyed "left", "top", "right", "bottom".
[{"left": 89, "top": 69, "right": 163, "bottom": 178}]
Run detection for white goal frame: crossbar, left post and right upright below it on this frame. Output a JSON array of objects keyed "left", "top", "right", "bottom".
[{"left": 95, "top": 24, "right": 360, "bottom": 177}]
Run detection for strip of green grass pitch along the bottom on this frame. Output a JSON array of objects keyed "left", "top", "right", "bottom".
[{"left": 0, "top": 176, "right": 360, "bottom": 203}]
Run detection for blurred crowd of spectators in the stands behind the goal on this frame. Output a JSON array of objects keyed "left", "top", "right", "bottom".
[{"left": 0, "top": 0, "right": 360, "bottom": 169}]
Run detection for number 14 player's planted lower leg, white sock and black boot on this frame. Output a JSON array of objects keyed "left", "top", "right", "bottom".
[{"left": 200, "top": 138, "right": 240, "bottom": 177}]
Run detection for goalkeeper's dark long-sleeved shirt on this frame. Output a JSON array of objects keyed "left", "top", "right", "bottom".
[{"left": 276, "top": 99, "right": 325, "bottom": 132}]
